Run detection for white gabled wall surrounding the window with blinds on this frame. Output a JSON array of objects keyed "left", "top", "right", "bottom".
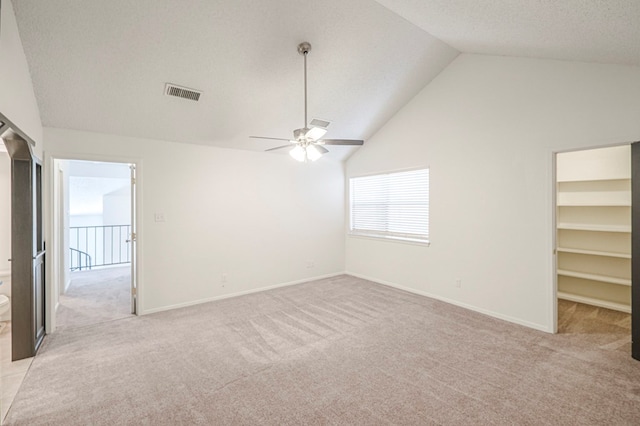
[{"left": 346, "top": 54, "right": 640, "bottom": 331}]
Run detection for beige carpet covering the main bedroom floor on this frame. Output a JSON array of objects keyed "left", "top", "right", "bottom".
[{"left": 7, "top": 276, "right": 640, "bottom": 425}]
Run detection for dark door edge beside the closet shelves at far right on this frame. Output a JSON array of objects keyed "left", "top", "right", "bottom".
[{"left": 631, "top": 142, "right": 640, "bottom": 360}]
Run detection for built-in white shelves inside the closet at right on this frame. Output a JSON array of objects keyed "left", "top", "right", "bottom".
[{"left": 556, "top": 146, "right": 631, "bottom": 312}]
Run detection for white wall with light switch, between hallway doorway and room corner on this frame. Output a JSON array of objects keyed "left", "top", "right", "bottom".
[{"left": 44, "top": 128, "right": 345, "bottom": 313}]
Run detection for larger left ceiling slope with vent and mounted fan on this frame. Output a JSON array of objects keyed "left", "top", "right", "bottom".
[{"left": 13, "top": 0, "right": 458, "bottom": 158}]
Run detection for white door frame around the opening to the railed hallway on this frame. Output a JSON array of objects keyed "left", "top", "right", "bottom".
[{"left": 44, "top": 151, "right": 144, "bottom": 334}]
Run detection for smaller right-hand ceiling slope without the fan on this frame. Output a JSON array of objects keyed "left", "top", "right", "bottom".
[{"left": 376, "top": 0, "right": 640, "bottom": 65}]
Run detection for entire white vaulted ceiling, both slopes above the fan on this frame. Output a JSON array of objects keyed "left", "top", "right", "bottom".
[{"left": 12, "top": 0, "right": 640, "bottom": 158}]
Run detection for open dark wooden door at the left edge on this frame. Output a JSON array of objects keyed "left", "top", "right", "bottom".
[{"left": 0, "top": 116, "right": 45, "bottom": 361}]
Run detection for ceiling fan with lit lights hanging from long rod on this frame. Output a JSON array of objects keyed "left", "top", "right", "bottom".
[{"left": 249, "top": 41, "right": 364, "bottom": 162}]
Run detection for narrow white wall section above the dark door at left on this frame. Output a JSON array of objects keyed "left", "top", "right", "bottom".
[{"left": 0, "top": 0, "right": 42, "bottom": 151}]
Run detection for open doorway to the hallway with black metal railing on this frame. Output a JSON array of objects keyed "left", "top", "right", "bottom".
[{"left": 53, "top": 159, "right": 136, "bottom": 329}]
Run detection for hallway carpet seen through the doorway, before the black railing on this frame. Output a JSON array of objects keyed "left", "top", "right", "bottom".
[{"left": 56, "top": 266, "right": 131, "bottom": 329}]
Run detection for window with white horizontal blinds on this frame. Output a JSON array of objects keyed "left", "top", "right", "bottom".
[{"left": 349, "top": 169, "right": 429, "bottom": 243}]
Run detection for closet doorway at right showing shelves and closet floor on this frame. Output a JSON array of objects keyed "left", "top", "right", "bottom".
[{"left": 555, "top": 144, "right": 632, "bottom": 353}]
